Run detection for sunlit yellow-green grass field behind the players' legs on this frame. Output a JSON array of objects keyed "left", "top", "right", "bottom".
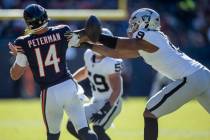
[{"left": 0, "top": 98, "right": 210, "bottom": 140}]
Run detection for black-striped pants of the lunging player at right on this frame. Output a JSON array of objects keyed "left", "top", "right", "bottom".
[{"left": 147, "top": 68, "right": 210, "bottom": 118}]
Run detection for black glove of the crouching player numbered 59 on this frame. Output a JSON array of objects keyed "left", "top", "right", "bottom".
[{"left": 90, "top": 102, "right": 112, "bottom": 123}]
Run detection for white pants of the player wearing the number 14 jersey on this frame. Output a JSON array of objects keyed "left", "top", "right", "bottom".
[{"left": 41, "top": 80, "right": 88, "bottom": 134}]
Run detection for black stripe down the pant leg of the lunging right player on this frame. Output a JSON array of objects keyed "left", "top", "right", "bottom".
[{"left": 148, "top": 77, "right": 187, "bottom": 112}]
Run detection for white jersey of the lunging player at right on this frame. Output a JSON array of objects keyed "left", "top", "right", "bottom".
[{"left": 133, "top": 30, "right": 203, "bottom": 80}]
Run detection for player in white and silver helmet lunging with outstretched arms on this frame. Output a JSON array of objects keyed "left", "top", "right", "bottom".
[{"left": 68, "top": 8, "right": 210, "bottom": 140}]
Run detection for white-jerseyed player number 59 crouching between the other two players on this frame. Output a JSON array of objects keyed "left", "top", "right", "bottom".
[{"left": 67, "top": 28, "right": 123, "bottom": 140}]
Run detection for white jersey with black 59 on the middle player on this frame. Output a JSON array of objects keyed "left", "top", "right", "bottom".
[{"left": 84, "top": 49, "right": 123, "bottom": 99}]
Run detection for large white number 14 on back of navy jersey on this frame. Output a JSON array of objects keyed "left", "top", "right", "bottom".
[{"left": 35, "top": 44, "right": 60, "bottom": 77}]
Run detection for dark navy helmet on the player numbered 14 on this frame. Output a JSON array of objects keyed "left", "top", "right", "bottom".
[{"left": 23, "top": 4, "right": 49, "bottom": 30}]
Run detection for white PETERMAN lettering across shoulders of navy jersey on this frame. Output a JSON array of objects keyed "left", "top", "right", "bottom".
[{"left": 28, "top": 33, "right": 61, "bottom": 48}]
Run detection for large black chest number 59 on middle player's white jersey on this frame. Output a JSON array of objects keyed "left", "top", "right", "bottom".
[{"left": 88, "top": 72, "right": 109, "bottom": 92}]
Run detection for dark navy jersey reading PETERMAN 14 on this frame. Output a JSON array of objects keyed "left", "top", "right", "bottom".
[{"left": 14, "top": 25, "right": 71, "bottom": 88}]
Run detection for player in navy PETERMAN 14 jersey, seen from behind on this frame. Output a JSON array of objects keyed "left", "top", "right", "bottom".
[{"left": 9, "top": 4, "right": 97, "bottom": 140}]
